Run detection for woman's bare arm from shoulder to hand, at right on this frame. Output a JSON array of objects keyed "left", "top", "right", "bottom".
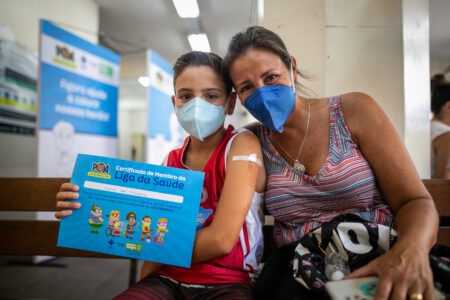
[{"left": 342, "top": 93, "right": 439, "bottom": 299}]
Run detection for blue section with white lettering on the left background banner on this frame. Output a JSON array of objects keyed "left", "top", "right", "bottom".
[{"left": 39, "top": 64, "right": 118, "bottom": 136}]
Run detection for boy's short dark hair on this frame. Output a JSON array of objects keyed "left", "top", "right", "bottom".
[{"left": 173, "top": 51, "right": 233, "bottom": 95}]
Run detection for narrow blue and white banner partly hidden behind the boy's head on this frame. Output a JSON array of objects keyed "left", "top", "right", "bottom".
[{"left": 146, "top": 50, "right": 186, "bottom": 164}]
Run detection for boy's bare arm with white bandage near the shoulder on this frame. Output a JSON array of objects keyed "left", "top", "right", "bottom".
[{"left": 192, "top": 133, "right": 265, "bottom": 263}]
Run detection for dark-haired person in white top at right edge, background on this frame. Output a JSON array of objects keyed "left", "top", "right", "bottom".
[{"left": 430, "top": 83, "right": 450, "bottom": 179}]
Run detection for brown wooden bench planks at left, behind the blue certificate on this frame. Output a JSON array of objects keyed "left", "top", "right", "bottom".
[{"left": 0, "top": 178, "right": 137, "bottom": 285}]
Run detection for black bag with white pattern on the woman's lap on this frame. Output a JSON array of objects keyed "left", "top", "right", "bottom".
[{"left": 293, "top": 214, "right": 450, "bottom": 297}]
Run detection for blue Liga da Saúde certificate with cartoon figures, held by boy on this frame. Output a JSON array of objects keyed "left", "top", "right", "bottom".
[{"left": 58, "top": 154, "right": 204, "bottom": 267}]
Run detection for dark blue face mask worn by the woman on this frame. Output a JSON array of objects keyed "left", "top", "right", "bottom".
[{"left": 244, "top": 71, "right": 296, "bottom": 132}]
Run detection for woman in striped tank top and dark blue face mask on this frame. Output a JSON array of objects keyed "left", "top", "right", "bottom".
[{"left": 224, "top": 26, "right": 438, "bottom": 300}]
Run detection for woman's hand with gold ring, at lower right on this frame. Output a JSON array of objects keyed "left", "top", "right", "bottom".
[{"left": 345, "top": 243, "right": 434, "bottom": 300}]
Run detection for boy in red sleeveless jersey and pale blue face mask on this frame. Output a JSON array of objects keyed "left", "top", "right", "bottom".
[{"left": 55, "top": 51, "right": 265, "bottom": 299}]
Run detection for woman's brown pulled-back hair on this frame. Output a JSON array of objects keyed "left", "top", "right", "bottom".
[{"left": 223, "top": 26, "right": 311, "bottom": 92}]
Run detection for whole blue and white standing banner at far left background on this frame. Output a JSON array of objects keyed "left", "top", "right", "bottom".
[{"left": 38, "top": 20, "right": 120, "bottom": 177}]
